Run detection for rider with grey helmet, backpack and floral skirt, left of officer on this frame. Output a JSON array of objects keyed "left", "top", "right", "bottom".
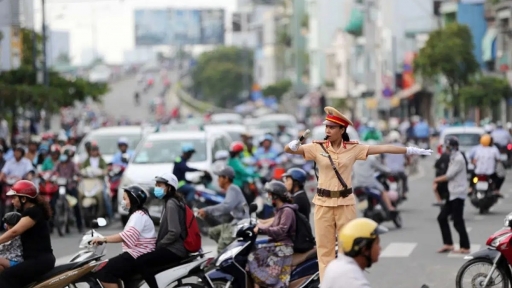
[{"left": 246, "top": 180, "right": 297, "bottom": 288}]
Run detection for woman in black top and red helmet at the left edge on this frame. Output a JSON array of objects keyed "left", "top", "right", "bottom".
[{"left": 0, "top": 180, "right": 55, "bottom": 288}]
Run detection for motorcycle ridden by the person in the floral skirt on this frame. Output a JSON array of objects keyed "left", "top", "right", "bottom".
[{"left": 206, "top": 204, "right": 320, "bottom": 288}]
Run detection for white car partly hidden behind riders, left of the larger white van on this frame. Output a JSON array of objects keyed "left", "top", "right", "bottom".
[{"left": 73, "top": 126, "right": 155, "bottom": 163}]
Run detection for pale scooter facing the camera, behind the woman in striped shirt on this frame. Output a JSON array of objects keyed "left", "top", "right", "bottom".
[{"left": 78, "top": 166, "right": 105, "bottom": 227}]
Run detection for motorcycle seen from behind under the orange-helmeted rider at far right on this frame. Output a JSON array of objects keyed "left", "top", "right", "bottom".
[{"left": 470, "top": 175, "right": 498, "bottom": 214}]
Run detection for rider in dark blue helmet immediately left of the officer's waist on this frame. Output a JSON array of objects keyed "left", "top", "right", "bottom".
[{"left": 283, "top": 168, "right": 311, "bottom": 220}]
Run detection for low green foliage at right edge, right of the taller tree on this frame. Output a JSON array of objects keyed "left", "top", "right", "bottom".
[{"left": 459, "top": 76, "right": 511, "bottom": 109}]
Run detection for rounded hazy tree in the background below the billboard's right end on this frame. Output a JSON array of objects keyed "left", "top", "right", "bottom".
[{"left": 192, "top": 47, "right": 253, "bottom": 107}]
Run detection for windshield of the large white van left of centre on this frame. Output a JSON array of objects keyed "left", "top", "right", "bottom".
[{"left": 133, "top": 139, "right": 207, "bottom": 164}]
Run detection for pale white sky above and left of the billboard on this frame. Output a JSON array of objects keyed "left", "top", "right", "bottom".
[{"left": 34, "top": 0, "right": 236, "bottom": 64}]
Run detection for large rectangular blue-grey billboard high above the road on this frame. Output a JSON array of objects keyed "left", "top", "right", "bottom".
[{"left": 135, "top": 9, "right": 224, "bottom": 46}]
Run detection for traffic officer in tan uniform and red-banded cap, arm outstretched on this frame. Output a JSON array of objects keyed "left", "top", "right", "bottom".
[{"left": 285, "top": 107, "right": 432, "bottom": 280}]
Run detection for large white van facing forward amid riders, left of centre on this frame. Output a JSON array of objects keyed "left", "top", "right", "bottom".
[{"left": 117, "top": 130, "right": 231, "bottom": 223}]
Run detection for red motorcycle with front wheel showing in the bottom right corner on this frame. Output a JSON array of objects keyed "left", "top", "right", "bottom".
[{"left": 455, "top": 213, "right": 512, "bottom": 288}]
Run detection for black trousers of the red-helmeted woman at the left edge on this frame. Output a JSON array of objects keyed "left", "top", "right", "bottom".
[{"left": 0, "top": 253, "right": 55, "bottom": 288}]
